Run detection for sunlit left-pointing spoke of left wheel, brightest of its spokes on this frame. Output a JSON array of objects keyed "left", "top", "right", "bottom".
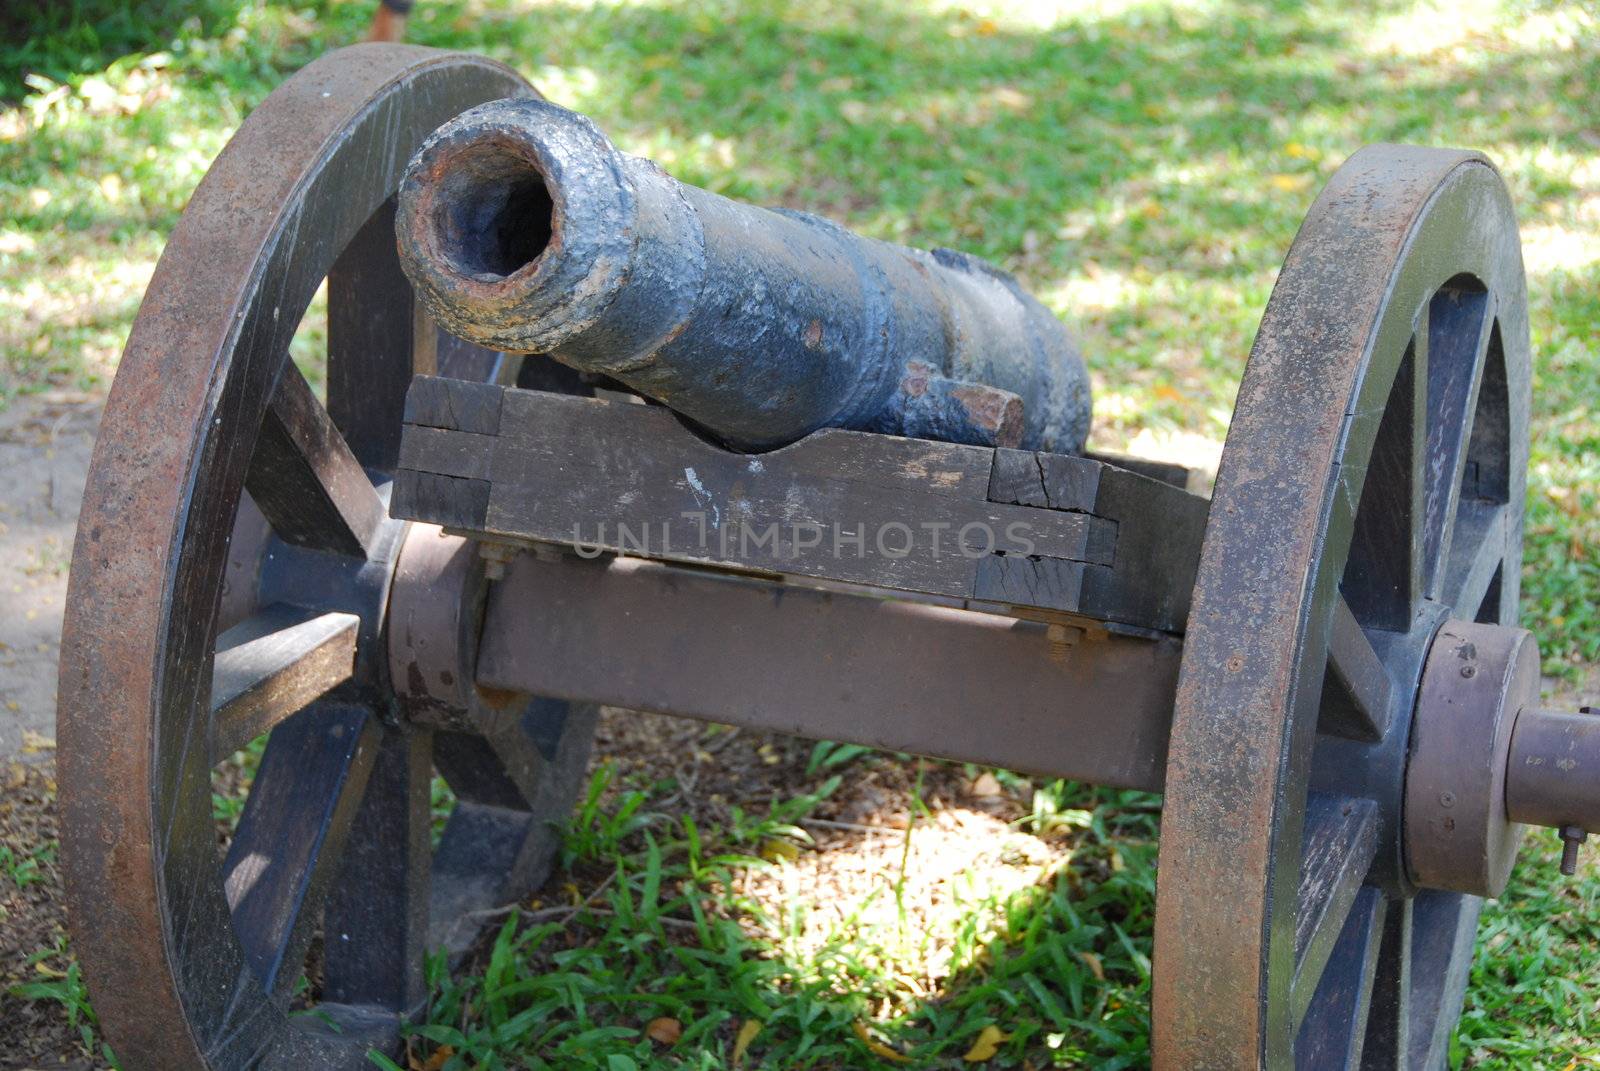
[{"left": 210, "top": 605, "right": 362, "bottom": 765}]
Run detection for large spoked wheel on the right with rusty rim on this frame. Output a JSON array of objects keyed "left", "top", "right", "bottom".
[{"left": 1152, "top": 146, "right": 1538, "bottom": 1071}]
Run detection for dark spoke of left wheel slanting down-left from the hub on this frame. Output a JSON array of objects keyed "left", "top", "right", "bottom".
[{"left": 222, "top": 703, "right": 378, "bottom": 996}]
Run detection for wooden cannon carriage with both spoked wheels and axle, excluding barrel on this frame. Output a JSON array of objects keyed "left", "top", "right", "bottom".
[{"left": 58, "top": 45, "right": 1600, "bottom": 1071}]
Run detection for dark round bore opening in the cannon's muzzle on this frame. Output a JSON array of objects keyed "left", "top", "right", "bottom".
[{"left": 434, "top": 142, "right": 557, "bottom": 282}]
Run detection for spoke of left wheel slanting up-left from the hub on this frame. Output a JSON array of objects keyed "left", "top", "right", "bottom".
[{"left": 245, "top": 359, "right": 386, "bottom": 557}]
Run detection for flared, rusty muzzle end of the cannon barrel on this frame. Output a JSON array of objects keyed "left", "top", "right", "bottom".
[{"left": 395, "top": 98, "right": 638, "bottom": 352}]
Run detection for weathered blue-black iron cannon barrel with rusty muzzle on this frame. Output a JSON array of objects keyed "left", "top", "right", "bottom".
[{"left": 395, "top": 98, "right": 1090, "bottom": 451}]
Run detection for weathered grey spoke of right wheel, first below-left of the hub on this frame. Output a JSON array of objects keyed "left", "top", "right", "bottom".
[{"left": 1291, "top": 792, "right": 1378, "bottom": 1021}]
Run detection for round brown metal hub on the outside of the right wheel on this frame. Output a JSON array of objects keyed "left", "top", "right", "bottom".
[{"left": 1405, "top": 621, "right": 1539, "bottom": 897}]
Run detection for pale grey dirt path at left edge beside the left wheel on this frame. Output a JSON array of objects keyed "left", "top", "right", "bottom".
[{"left": 0, "top": 394, "right": 102, "bottom": 760}]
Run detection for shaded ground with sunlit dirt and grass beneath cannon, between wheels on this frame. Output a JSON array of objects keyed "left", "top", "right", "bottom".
[{"left": 413, "top": 730, "right": 1155, "bottom": 1071}]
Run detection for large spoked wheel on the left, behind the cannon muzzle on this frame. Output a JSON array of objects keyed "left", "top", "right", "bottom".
[{"left": 59, "top": 45, "right": 594, "bottom": 1071}]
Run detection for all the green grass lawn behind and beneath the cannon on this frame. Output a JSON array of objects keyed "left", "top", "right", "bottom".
[{"left": 0, "top": 0, "right": 1600, "bottom": 1071}]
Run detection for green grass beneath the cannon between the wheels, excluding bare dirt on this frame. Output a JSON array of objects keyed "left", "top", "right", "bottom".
[{"left": 378, "top": 757, "right": 1155, "bottom": 1071}]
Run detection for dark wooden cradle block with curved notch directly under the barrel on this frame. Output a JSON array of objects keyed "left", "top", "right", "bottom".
[{"left": 390, "top": 384, "right": 1206, "bottom": 632}]
